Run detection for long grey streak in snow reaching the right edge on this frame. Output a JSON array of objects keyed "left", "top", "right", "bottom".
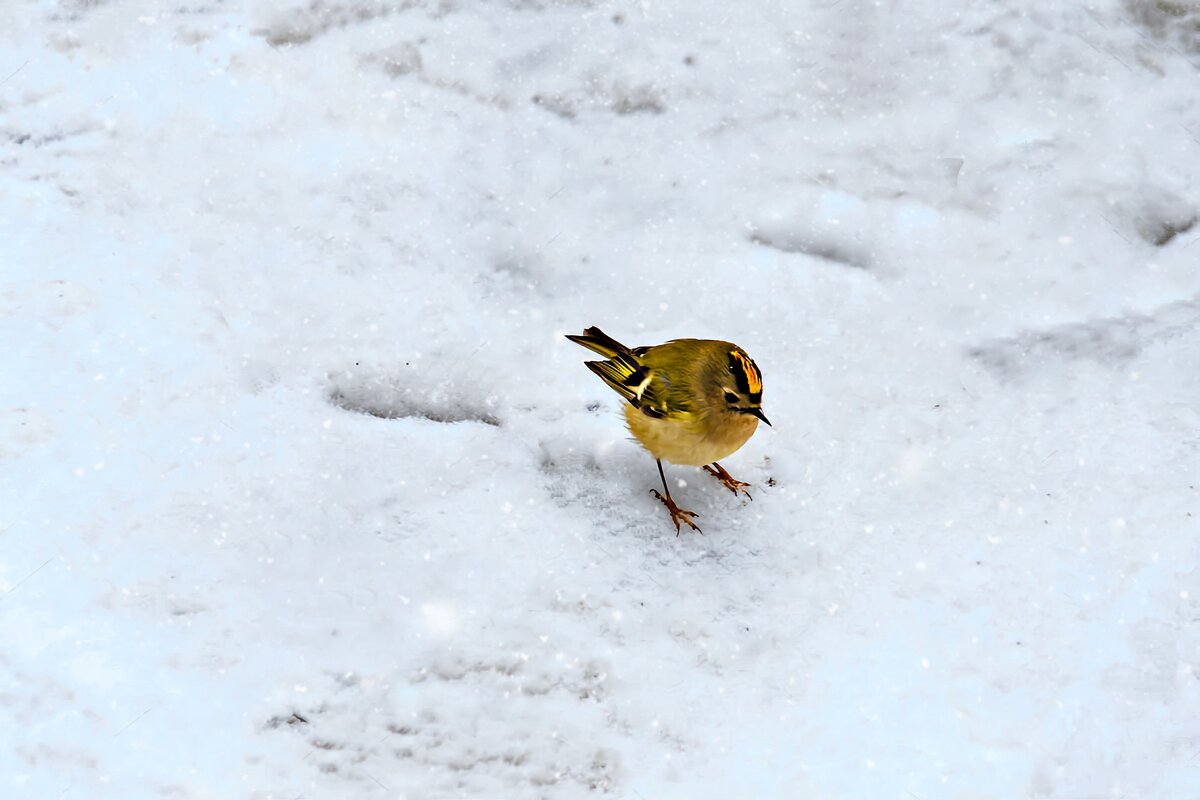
[{"left": 967, "top": 296, "right": 1200, "bottom": 378}]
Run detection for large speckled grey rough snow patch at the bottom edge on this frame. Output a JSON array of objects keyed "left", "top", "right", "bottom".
[{"left": 263, "top": 671, "right": 619, "bottom": 796}]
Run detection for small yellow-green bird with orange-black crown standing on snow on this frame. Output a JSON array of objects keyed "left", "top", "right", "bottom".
[{"left": 566, "top": 327, "right": 770, "bottom": 536}]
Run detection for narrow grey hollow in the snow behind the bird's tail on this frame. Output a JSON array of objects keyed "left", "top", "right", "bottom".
[{"left": 326, "top": 372, "right": 500, "bottom": 426}]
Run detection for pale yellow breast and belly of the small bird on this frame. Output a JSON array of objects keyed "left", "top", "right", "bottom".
[{"left": 625, "top": 405, "right": 758, "bottom": 467}]
